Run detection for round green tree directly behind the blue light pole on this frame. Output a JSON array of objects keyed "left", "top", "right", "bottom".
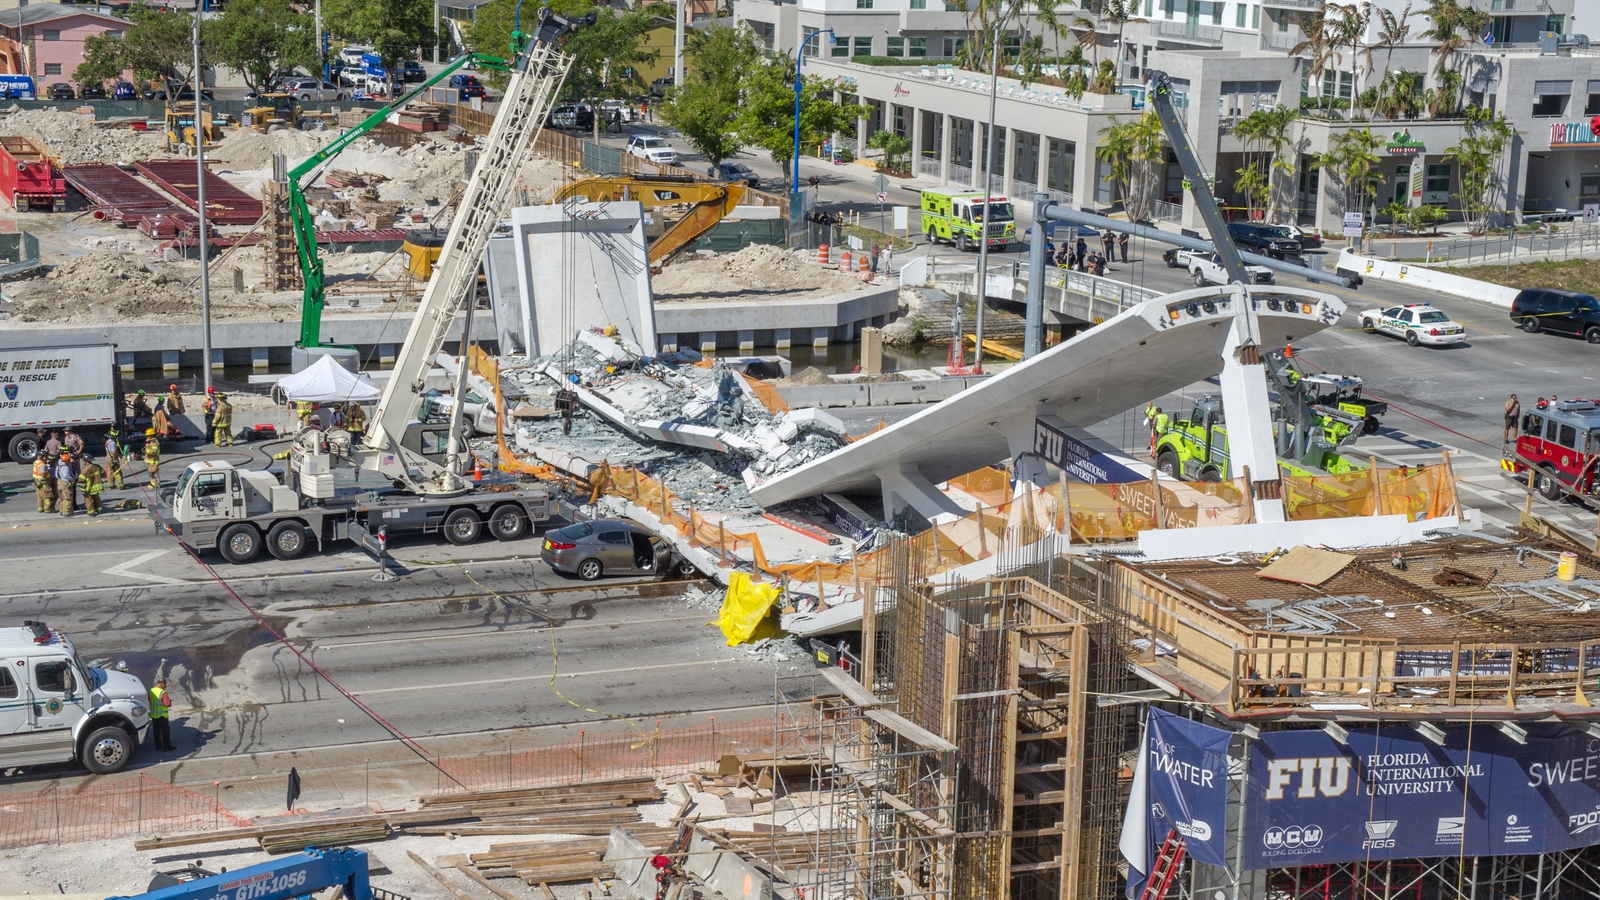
[{"left": 734, "top": 56, "right": 856, "bottom": 168}]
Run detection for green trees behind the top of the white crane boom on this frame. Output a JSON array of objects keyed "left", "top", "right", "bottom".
[{"left": 467, "top": 0, "right": 659, "bottom": 99}]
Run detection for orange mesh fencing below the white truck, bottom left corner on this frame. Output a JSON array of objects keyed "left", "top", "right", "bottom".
[{"left": 0, "top": 772, "right": 250, "bottom": 849}]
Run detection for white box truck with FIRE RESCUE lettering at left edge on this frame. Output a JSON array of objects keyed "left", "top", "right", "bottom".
[{"left": 0, "top": 331, "right": 123, "bottom": 466}]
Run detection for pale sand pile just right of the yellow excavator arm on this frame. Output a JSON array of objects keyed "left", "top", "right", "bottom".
[{"left": 651, "top": 243, "right": 862, "bottom": 303}]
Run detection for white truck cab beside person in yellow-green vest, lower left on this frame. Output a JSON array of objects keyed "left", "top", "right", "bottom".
[{"left": 0, "top": 621, "right": 150, "bottom": 775}]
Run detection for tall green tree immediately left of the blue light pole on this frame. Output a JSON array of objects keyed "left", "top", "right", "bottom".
[{"left": 661, "top": 26, "right": 766, "bottom": 165}]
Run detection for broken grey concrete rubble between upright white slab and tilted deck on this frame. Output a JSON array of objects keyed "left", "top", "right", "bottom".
[{"left": 502, "top": 331, "right": 845, "bottom": 509}]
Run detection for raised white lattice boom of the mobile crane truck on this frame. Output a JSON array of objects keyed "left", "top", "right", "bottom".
[{"left": 357, "top": 8, "right": 594, "bottom": 495}]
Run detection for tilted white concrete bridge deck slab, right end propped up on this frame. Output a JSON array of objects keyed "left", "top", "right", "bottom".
[{"left": 750, "top": 285, "right": 1344, "bottom": 517}]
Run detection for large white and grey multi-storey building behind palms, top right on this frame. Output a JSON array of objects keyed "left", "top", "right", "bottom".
[{"left": 734, "top": 0, "right": 1600, "bottom": 231}]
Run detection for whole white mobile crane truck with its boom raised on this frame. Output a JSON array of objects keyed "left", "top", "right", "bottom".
[{"left": 150, "top": 8, "right": 595, "bottom": 562}]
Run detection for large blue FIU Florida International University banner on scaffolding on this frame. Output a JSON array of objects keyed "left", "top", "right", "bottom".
[{"left": 1245, "top": 722, "right": 1600, "bottom": 868}]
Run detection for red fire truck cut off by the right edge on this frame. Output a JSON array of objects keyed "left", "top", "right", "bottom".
[{"left": 1501, "top": 400, "right": 1600, "bottom": 499}]
